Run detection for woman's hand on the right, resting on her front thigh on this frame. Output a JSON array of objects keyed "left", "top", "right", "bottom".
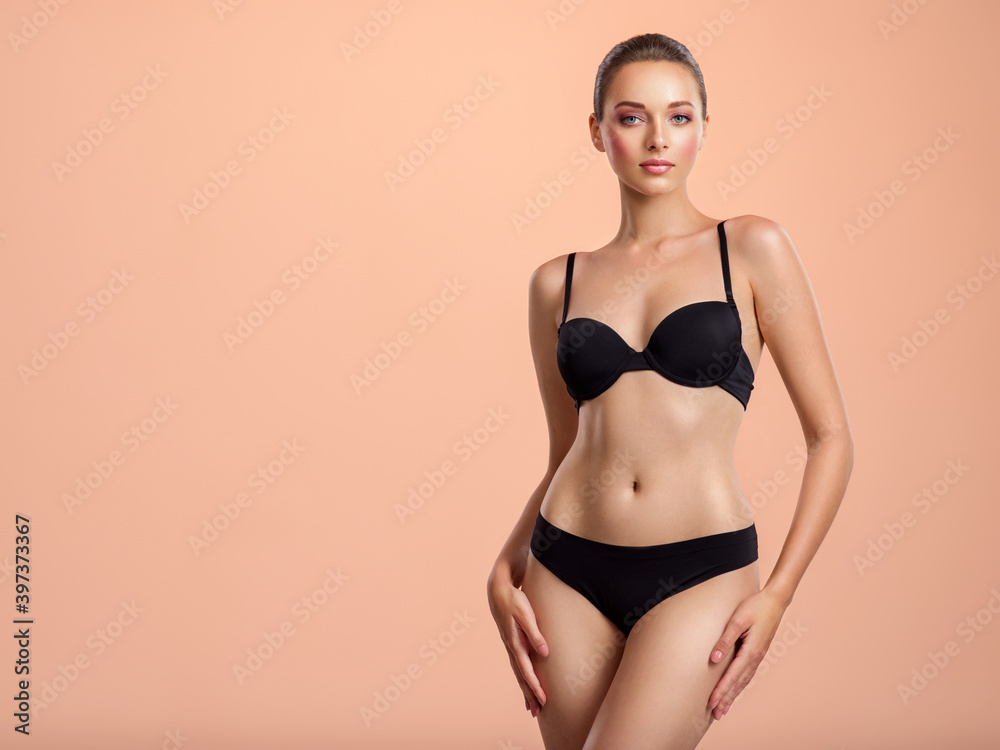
[{"left": 708, "top": 589, "right": 787, "bottom": 719}]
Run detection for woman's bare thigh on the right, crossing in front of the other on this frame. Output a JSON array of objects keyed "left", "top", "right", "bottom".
[{"left": 583, "top": 562, "right": 759, "bottom": 750}]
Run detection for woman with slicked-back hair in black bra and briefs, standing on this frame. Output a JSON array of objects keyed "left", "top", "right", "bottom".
[{"left": 488, "top": 34, "right": 854, "bottom": 750}]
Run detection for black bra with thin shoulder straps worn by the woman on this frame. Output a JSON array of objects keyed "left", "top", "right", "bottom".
[{"left": 556, "top": 221, "right": 754, "bottom": 411}]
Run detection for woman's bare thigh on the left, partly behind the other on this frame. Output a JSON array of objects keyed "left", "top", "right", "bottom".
[{"left": 521, "top": 553, "right": 625, "bottom": 750}]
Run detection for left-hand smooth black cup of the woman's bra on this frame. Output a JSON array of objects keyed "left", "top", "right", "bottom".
[{"left": 556, "top": 318, "right": 632, "bottom": 394}]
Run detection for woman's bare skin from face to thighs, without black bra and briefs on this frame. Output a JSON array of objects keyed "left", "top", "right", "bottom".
[{"left": 487, "top": 61, "right": 854, "bottom": 750}]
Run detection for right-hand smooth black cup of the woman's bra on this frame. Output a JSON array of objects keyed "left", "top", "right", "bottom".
[{"left": 646, "top": 301, "right": 743, "bottom": 386}]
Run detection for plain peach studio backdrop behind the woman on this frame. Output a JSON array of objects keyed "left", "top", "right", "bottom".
[{"left": 0, "top": 0, "right": 1000, "bottom": 750}]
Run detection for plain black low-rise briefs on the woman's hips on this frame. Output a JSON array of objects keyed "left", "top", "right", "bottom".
[{"left": 530, "top": 512, "right": 757, "bottom": 638}]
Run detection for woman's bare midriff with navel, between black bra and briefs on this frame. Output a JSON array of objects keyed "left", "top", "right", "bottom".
[{"left": 541, "top": 368, "right": 756, "bottom": 546}]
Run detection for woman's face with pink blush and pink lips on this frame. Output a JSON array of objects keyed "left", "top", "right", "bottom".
[{"left": 590, "top": 60, "right": 709, "bottom": 195}]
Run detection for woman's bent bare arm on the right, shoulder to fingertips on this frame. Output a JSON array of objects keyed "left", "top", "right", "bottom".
[{"left": 709, "top": 217, "right": 854, "bottom": 719}]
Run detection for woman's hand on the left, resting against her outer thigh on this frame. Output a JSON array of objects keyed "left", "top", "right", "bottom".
[{"left": 487, "top": 580, "right": 549, "bottom": 717}]
